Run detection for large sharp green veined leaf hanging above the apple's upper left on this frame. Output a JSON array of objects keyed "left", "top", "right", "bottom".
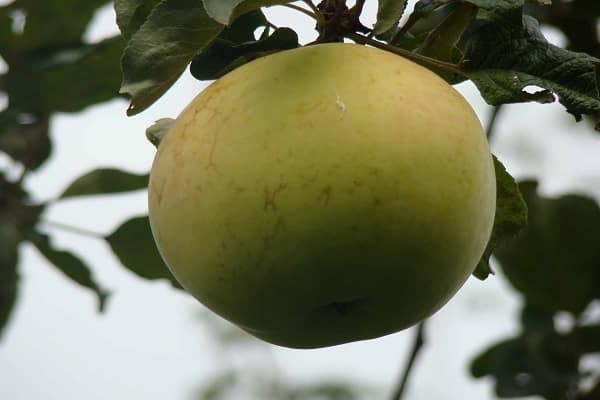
[{"left": 121, "top": 0, "right": 224, "bottom": 115}]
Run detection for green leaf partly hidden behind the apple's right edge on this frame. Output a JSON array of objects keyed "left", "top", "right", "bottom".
[{"left": 474, "top": 156, "right": 527, "bottom": 280}]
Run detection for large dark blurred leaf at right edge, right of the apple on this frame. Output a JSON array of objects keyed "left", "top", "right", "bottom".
[{"left": 494, "top": 181, "right": 600, "bottom": 314}]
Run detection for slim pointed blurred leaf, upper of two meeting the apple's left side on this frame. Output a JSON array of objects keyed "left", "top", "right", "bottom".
[{"left": 59, "top": 168, "right": 148, "bottom": 199}]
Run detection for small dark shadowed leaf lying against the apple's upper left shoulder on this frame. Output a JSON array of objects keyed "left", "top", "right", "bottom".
[{"left": 190, "top": 28, "right": 299, "bottom": 80}]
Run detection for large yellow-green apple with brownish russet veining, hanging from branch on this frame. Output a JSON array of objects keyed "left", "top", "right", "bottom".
[{"left": 149, "top": 43, "right": 496, "bottom": 348}]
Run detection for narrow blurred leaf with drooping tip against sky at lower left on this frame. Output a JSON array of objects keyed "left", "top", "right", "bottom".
[{"left": 30, "top": 233, "right": 109, "bottom": 312}]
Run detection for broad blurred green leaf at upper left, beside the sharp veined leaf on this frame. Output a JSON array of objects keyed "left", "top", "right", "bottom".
[{"left": 5, "top": 37, "right": 124, "bottom": 114}]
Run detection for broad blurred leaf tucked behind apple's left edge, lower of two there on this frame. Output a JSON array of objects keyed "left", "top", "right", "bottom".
[{"left": 106, "top": 216, "right": 181, "bottom": 288}]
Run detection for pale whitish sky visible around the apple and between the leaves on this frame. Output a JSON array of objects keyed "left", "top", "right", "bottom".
[{"left": 0, "top": 0, "right": 600, "bottom": 400}]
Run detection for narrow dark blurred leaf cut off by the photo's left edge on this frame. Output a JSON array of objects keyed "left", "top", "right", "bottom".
[{"left": 0, "top": 222, "right": 21, "bottom": 337}]
